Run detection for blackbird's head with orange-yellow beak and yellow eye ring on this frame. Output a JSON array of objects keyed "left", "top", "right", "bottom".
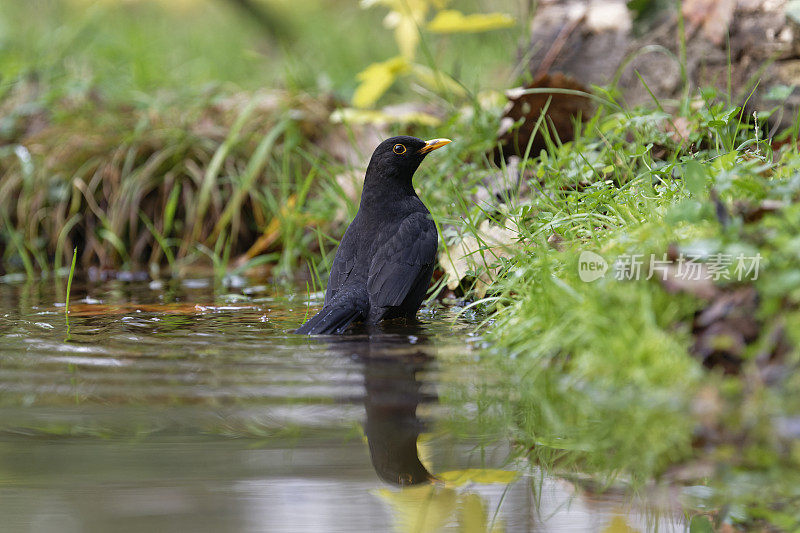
[{"left": 367, "top": 135, "right": 450, "bottom": 183}]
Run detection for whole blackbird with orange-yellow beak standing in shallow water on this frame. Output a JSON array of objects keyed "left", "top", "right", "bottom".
[{"left": 296, "top": 136, "right": 450, "bottom": 335}]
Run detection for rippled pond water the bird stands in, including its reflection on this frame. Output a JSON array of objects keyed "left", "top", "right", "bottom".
[{"left": 0, "top": 280, "right": 684, "bottom": 532}]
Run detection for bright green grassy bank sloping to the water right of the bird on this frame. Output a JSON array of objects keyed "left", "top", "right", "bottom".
[{"left": 434, "top": 93, "right": 800, "bottom": 529}]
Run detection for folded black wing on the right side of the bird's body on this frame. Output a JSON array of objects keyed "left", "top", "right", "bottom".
[{"left": 367, "top": 213, "right": 439, "bottom": 307}]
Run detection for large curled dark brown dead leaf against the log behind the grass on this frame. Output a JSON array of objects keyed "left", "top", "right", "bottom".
[{"left": 494, "top": 73, "right": 592, "bottom": 165}]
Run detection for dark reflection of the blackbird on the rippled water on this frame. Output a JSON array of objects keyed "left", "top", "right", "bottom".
[{"left": 331, "top": 324, "right": 436, "bottom": 486}]
